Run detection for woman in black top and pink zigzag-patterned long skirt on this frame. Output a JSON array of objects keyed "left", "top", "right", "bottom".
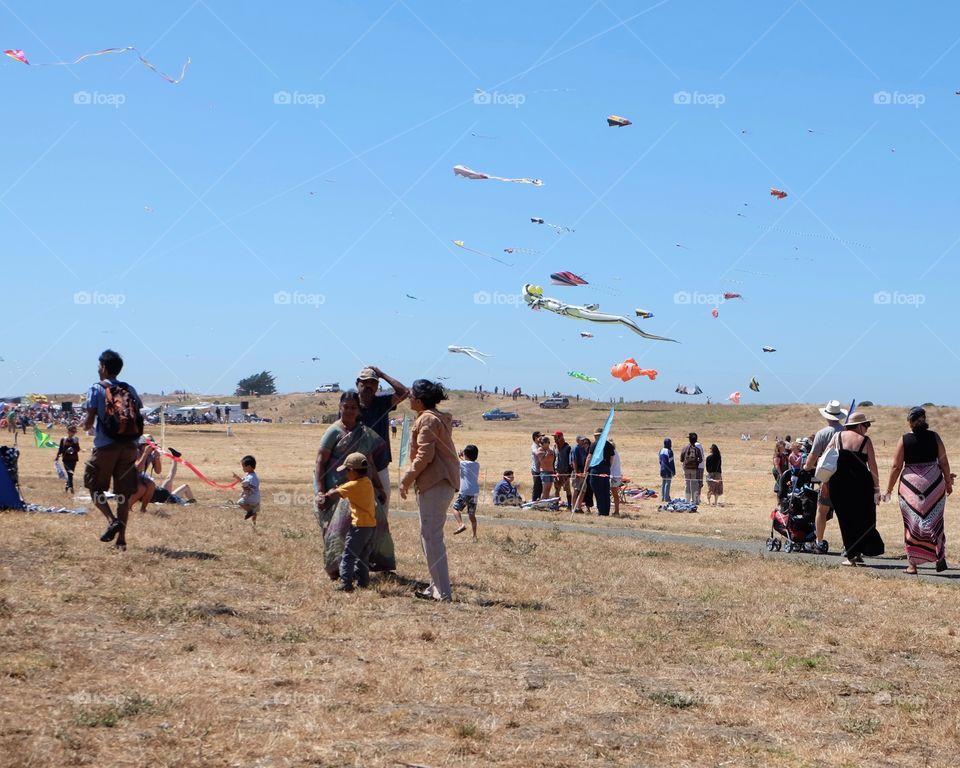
[{"left": 886, "top": 407, "right": 953, "bottom": 573}]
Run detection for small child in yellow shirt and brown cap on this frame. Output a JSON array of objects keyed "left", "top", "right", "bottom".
[{"left": 324, "top": 453, "right": 377, "bottom": 592}]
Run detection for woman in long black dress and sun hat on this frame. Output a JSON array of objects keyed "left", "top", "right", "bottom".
[{"left": 830, "top": 411, "right": 883, "bottom": 565}]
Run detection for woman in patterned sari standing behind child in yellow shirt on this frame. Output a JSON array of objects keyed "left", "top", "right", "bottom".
[{"left": 313, "top": 390, "right": 397, "bottom": 579}]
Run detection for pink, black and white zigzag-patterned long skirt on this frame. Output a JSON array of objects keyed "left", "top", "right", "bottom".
[{"left": 899, "top": 461, "right": 947, "bottom": 565}]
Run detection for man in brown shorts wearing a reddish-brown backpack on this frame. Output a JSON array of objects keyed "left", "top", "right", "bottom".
[{"left": 83, "top": 349, "right": 143, "bottom": 552}]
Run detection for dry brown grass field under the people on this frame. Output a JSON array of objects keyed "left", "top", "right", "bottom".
[{"left": 0, "top": 394, "right": 960, "bottom": 768}]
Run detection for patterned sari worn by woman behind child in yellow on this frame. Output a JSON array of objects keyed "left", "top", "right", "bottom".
[{"left": 314, "top": 421, "right": 397, "bottom": 579}]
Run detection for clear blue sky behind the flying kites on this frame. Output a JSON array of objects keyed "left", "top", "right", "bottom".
[{"left": 0, "top": 0, "right": 960, "bottom": 404}]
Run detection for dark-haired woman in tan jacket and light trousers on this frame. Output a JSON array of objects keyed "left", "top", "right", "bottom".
[{"left": 400, "top": 379, "right": 460, "bottom": 602}]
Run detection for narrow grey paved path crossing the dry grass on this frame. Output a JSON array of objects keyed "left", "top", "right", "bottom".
[{"left": 390, "top": 510, "right": 960, "bottom": 586}]
